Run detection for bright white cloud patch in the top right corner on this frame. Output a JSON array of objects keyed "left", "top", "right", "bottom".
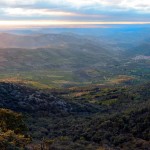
[{"left": 62, "top": 0, "right": 150, "bottom": 13}]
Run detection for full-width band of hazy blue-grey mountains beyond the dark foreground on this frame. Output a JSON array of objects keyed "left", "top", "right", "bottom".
[{"left": 0, "top": 31, "right": 150, "bottom": 86}]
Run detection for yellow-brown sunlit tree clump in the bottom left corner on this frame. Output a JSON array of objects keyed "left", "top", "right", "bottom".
[{"left": 0, "top": 109, "right": 31, "bottom": 150}]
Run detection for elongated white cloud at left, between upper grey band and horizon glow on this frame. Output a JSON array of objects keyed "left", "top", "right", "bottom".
[{"left": 0, "top": 8, "right": 106, "bottom": 21}]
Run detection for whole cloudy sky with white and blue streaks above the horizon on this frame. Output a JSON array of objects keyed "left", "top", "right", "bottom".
[{"left": 0, "top": 0, "right": 150, "bottom": 28}]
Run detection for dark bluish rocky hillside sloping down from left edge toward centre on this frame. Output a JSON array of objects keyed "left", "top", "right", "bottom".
[{"left": 0, "top": 83, "right": 98, "bottom": 116}]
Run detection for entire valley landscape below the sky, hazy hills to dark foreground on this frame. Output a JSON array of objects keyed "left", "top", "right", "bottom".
[{"left": 0, "top": 28, "right": 150, "bottom": 150}]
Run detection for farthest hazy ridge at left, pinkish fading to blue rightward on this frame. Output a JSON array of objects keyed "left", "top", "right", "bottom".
[{"left": 0, "top": 33, "right": 108, "bottom": 48}]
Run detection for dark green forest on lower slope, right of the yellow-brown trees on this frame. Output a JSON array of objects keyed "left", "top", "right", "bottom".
[{"left": 26, "top": 105, "right": 150, "bottom": 150}]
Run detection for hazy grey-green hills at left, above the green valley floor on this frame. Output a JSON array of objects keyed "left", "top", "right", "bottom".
[{"left": 0, "top": 34, "right": 117, "bottom": 70}]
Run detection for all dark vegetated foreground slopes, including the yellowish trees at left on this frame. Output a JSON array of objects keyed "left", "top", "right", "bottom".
[{"left": 0, "top": 83, "right": 150, "bottom": 150}]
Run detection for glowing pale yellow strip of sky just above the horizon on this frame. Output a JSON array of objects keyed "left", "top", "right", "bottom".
[{"left": 0, "top": 20, "right": 150, "bottom": 28}]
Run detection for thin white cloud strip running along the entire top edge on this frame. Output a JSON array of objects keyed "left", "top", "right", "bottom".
[{"left": 0, "top": 0, "right": 150, "bottom": 12}]
